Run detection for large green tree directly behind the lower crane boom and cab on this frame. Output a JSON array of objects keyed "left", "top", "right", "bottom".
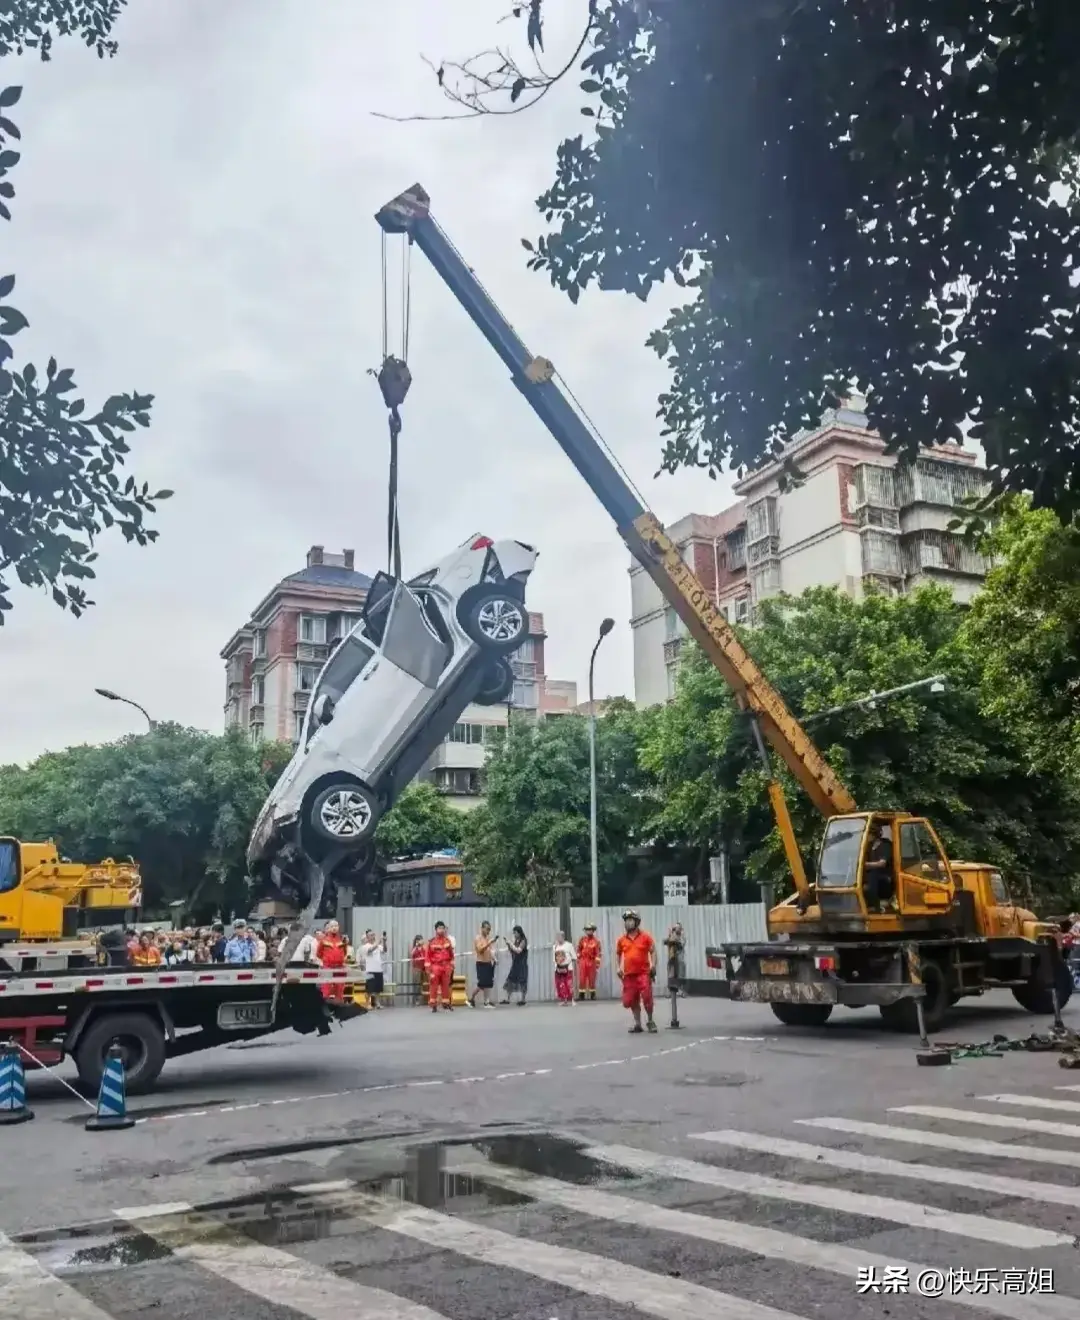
[{"left": 642, "top": 587, "right": 1080, "bottom": 894}]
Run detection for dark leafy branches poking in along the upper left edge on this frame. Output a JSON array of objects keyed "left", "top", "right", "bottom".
[{"left": 0, "top": 0, "right": 172, "bottom": 624}]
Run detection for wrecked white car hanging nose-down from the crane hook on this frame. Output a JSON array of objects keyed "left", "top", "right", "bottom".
[{"left": 247, "top": 536, "right": 536, "bottom": 874}]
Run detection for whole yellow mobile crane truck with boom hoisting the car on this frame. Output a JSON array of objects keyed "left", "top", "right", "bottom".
[{"left": 375, "top": 183, "right": 1072, "bottom": 1030}]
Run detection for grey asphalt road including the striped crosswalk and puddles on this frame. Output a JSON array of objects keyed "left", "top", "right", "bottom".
[{"left": 0, "top": 999, "right": 1080, "bottom": 1320}]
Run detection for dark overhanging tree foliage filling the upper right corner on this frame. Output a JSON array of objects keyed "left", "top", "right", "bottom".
[{"left": 519, "top": 0, "right": 1080, "bottom": 513}]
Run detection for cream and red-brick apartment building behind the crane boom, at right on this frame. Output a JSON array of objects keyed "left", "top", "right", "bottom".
[{"left": 630, "top": 400, "right": 988, "bottom": 706}]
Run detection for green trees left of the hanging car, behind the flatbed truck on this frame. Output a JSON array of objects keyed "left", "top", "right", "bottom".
[{"left": 0, "top": 725, "right": 290, "bottom": 913}]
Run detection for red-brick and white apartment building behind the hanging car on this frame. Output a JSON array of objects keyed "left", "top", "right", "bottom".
[{"left": 220, "top": 545, "right": 577, "bottom": 809}]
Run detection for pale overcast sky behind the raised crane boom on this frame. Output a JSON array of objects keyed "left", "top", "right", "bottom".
[{"left": 0, "top": 0, "right": 729, "bottom": 763}]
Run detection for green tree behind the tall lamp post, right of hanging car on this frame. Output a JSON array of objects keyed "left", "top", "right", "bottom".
[{"left": 463, "top": 701, "right": 651, "bottom": 903}]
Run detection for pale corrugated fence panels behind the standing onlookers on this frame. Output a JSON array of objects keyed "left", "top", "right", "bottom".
[{"left": 351, "top": 903, "right": 766, "bottom": 1003}]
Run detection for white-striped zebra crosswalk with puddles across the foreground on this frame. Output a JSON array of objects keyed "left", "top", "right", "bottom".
[{"left": 0, "top": 1086, "right": 1080, "bottom": 1320}]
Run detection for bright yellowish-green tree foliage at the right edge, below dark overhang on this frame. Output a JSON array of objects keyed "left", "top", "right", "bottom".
[{"left": 964, "top": 500, "right": 1080, "bottom": 776}]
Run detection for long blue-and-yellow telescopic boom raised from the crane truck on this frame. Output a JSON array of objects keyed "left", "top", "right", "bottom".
[{"left": 375, "top": 183, "right": 856, "bottom": 823}]
